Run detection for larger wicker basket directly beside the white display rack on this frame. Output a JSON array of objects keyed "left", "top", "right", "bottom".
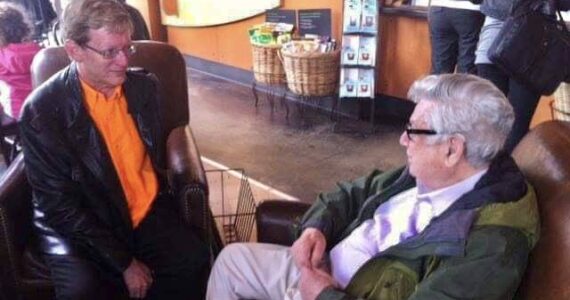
[{"left": 280, "top": 50, "right": 340, "bottom": 96}]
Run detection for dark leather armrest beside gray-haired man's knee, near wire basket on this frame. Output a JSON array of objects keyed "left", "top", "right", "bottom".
[{"left": 255, "top": 200, "right": 311, "bottom": 246}]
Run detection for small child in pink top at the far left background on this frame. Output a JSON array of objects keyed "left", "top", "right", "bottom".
[{"left": 0, "top": 2, "right": 40, "bottom": 119}]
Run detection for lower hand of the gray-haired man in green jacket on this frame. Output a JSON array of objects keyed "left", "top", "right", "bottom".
[{"left": 299, "top": 267, "right": 338, "bottom": 300}]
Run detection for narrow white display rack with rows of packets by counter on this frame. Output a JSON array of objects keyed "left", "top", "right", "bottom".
[{"left": 336, "top": 0, "right": 379, "bottom": 131}]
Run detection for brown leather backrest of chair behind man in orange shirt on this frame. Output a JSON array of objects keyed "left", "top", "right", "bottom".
[{"left": 32, "top": 41, "right": 189, "bottom": 137}]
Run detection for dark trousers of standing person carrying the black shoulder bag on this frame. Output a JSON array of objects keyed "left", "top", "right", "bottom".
[{"left": 477, "top": 64, "right": 540, "bottom": 153}]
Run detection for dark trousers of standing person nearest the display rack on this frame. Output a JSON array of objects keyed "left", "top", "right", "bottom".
[{"left": 429, "top": 6, "right": 485, "bottom": 74}]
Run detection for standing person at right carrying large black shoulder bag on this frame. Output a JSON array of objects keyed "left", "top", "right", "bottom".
[{"left": 475, "top": 0, "right": 570, "bottom": 152}]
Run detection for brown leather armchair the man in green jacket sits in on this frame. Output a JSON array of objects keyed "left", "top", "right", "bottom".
[{"left": 256, "top": 121, "right": 570, "bottom": 300}]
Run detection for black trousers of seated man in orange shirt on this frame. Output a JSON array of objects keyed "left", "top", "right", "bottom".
[{"left": 45, "top": 198, "right": 209, "bottom": 299}]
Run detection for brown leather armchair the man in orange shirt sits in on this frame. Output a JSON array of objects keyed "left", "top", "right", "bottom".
[{"left": 0, "top": 41, "right": 221, "bottom": 299}]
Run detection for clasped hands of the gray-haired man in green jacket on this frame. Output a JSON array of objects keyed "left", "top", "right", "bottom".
[{"left": 291, "top": 228, "right": 338, "bottom": 300}]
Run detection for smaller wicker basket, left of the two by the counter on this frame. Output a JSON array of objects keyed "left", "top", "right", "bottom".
[{"left": 251, "top": 44, "right": 286, "bottom": 84}]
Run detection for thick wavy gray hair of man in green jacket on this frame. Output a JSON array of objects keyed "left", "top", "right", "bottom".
[{"left": 408, "top": 74, "right": 515, "bottom": 167}]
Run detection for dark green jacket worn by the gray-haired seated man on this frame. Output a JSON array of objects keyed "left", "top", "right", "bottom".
[{"left": 299, "top": 155, "right": 539, "bottom": 300}]
